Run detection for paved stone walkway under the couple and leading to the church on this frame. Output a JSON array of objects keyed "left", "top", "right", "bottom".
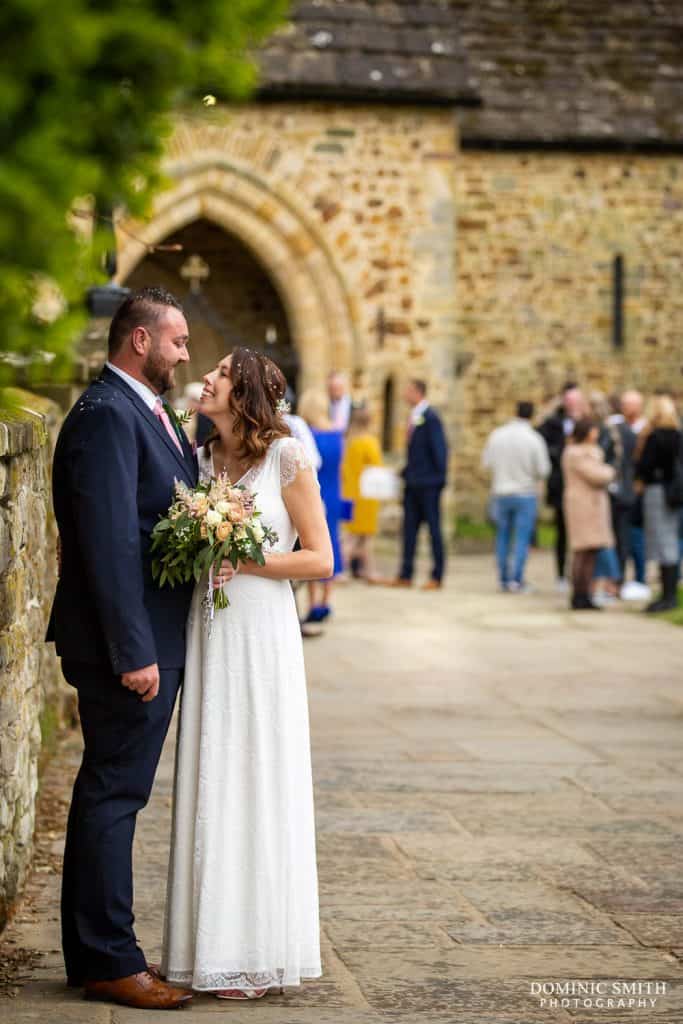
[{"left": 0, "top": 556, "right": 683, "bottom": 1024}]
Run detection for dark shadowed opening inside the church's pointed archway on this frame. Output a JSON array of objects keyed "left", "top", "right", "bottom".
[{"left": 125, "top": 218, "right": 299, "bottom": 394}]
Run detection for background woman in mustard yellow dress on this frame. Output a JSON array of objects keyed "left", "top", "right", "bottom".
[{"left": 342, "top": 409, "right": 382, "bottom": 583}]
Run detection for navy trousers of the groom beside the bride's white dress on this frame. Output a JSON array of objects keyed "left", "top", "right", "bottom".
[{"left": 61, "top": 660, "right": 181, "bottom": 984}]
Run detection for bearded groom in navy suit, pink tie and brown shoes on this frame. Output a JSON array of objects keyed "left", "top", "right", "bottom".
[{"left": 47, "top": 288, "right": 197, "bottom": 1010}]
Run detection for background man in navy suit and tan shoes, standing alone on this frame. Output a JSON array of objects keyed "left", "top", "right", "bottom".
[{"left": 391, "top": 380, "right": 449, "bottom": 590}]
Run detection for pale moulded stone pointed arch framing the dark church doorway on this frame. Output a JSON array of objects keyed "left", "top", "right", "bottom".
[{"left": 117, "top": 158, "right": 365, "bottom": 387}]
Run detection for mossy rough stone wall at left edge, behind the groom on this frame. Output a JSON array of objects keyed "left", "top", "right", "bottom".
[{"left": 0, "top": 392, "right": 66, "bottom": 929}]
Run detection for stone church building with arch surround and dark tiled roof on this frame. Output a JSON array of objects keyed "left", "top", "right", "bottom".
[{"left": 114, "top": 0, "right": 683, "bottom": 515}]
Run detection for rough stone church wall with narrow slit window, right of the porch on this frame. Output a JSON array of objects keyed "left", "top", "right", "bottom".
[{"left": 455, "top": 151, "right": 683, "bottom": 515}]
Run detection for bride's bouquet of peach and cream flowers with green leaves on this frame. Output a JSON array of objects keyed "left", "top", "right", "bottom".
[{"left": 152, "top": 474, "right": 278, "bottom": 617}]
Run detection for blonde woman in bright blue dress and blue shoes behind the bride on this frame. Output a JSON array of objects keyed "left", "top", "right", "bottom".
[{"left": 298, "top": 390, "right": 344, "bottom": 623}]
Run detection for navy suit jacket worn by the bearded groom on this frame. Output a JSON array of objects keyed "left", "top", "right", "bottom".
[{"left": 47, "top": 368, "right": 197, "bottom": 675}]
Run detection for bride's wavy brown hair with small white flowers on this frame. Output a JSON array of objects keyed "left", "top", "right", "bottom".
[{"left": 206, "top": 346, "right": 291, "bottom": 462}]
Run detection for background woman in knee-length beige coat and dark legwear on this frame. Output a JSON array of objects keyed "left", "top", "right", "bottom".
[{"left": 562, "top": 419, "right": 614, "bottom": 610}]
